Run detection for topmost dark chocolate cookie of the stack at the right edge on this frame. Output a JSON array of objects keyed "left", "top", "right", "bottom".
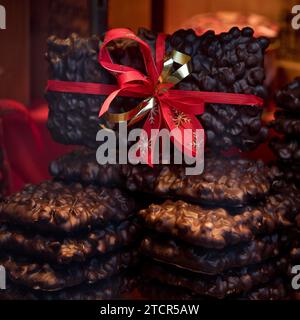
[{"left": 276, "top": 77, "right": 300, "bottom": 112}]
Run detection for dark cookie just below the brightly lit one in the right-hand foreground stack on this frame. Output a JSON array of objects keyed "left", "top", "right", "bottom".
[{"left": 141, "top": 234, "right": 289, "bottom": 275}]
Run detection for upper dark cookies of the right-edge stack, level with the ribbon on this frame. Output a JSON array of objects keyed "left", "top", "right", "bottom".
[{"left": 270, "top": 78, "right": 300, "bottom": 186}]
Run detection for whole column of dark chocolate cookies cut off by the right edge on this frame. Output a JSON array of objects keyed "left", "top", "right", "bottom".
[{"left": 270, "top": 78, "right": 300, "bottom": 299}]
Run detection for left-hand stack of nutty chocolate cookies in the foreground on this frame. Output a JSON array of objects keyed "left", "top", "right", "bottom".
[{"left": 0, "top": 181, "right": 140, "bottom": 299}]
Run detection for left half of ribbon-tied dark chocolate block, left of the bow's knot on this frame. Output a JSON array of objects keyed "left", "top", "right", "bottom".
[{"left": 46, "top": 34, "right": 143, "bottom": 147}]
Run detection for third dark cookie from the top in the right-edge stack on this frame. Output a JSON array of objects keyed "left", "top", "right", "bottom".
[{"left": 270, "top": 137, "right": 300, "bottom": 166}]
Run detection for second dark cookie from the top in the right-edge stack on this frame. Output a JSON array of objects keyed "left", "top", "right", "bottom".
[{"left": 270, "top": 111, "right": 300, "bottom": 137}]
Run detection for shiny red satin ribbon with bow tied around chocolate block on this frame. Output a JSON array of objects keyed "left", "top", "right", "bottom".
[{"left": 47, "top": 29, "right": 263, "bottom": 165}]
